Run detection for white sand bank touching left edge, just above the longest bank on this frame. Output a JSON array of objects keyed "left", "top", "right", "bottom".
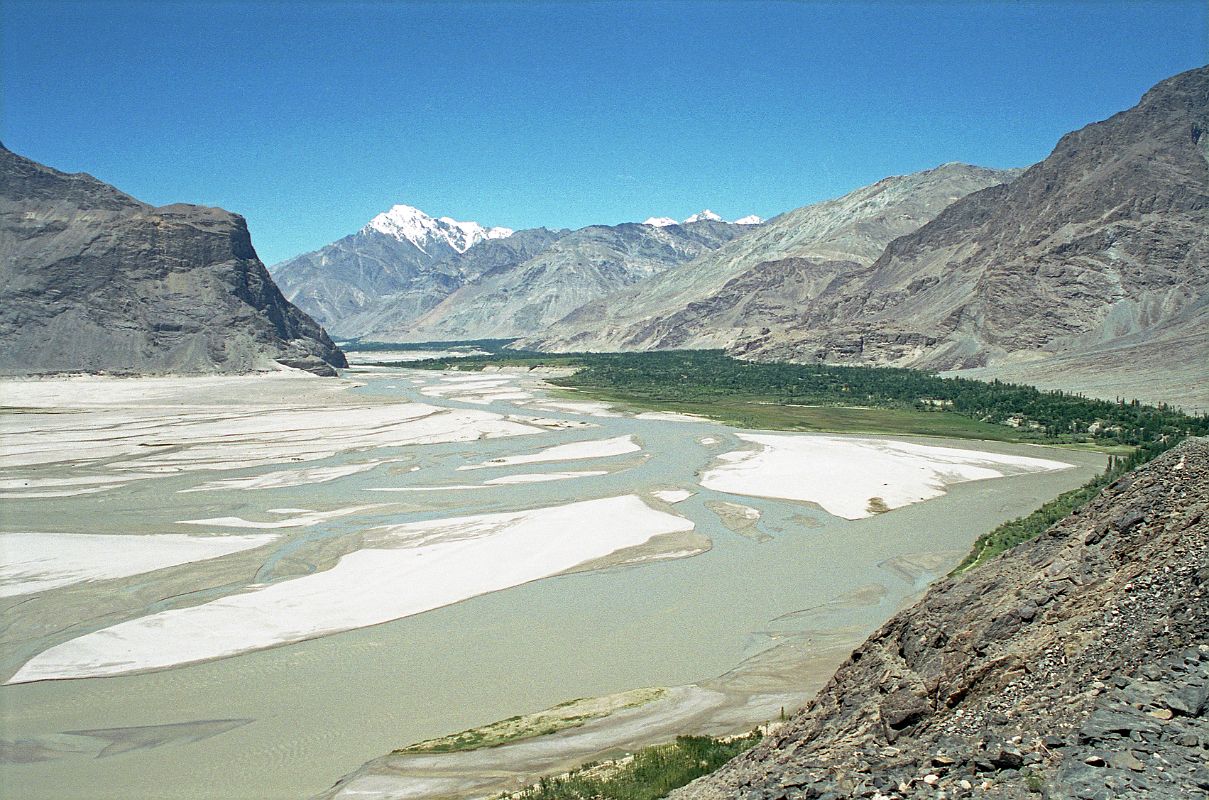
[{"left": 0, "top": 533, "right": 278, "bottom": 597}]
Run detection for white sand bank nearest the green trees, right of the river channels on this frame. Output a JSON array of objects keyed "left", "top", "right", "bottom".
[{"left": 701, "top": 434, "right": 1072, "bottom": 520}]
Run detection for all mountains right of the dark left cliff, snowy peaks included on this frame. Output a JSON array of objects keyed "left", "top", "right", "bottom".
[{"left": 271, "top": 69, "right": 1209, "bottom": 411}]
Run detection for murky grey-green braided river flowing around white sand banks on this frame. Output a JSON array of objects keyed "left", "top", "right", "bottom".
[{"left": 0, "top": 367, "right": 1104, "bottom": 800}]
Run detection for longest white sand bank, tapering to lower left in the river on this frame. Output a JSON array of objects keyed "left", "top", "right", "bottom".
[{"left": 8, "top": 494, "right": 693, "bottom": 683}]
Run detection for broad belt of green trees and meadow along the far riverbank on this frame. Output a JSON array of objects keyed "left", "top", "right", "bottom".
[{"left": 407, "top": 350, "right": 1209, "bottom": 454}]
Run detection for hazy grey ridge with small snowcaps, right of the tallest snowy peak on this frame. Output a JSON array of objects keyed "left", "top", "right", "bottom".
[{"left": 370, "top": 213, "right": 756, "bottom": 342}]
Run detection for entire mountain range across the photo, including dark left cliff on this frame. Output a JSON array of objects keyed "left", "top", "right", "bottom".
[{"left": 0, "top": 68, "right": 1209, "bottom": 411}]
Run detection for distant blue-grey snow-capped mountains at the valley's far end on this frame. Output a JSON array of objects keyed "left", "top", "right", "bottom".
[{"left": 270, "top": 205, "right": 758, "bottom": 342}]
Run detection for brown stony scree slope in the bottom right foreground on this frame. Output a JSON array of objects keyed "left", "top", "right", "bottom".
[{"left": 671, "top": 439, "right": 1209, "bottom": 800}]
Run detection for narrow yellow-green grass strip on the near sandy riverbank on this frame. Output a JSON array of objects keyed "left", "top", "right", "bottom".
[{"left": 394, "top": 689, "right": 665, "bottom": 755}]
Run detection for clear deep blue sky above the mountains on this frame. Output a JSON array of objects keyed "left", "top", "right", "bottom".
[{"left": 0, "top": 0, "right": 1209, "bottom": 263}]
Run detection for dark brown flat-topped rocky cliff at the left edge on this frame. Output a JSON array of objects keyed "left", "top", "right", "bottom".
[{"left": 0, "top": 146, "right": 346, "bottom": 375}]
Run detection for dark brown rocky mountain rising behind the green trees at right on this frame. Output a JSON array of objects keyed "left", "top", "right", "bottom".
[{"left": 734, "top": 68, "right": 1209, "bottom": 408}]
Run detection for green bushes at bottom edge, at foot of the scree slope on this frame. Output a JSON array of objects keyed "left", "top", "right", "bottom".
[{"left": 509, "top": 731, "right": 760, "bottom": 800}]
